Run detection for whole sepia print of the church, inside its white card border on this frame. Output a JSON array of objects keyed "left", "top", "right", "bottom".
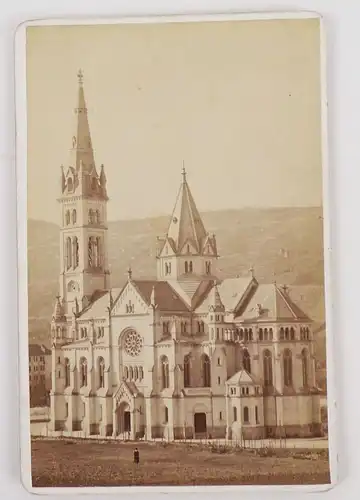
[{"left": 16, "top": 14, "right": 332, "bottom": 492}]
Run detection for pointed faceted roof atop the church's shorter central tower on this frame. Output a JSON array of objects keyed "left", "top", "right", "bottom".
[{"left": 167, "top": 168, "right": 207, "bottom": 253}]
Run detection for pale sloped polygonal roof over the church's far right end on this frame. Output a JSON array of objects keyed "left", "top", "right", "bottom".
[{"left": 241, "top": 283, "right": 310, "bottom": 321}]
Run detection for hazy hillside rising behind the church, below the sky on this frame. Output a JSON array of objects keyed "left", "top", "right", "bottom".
[{"left": 28, "top": 207, "right": 325, "bottom": 356}]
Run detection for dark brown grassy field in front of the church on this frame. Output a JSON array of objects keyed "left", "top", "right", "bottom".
[{"left": 32, "top": 439, "right": 330, "bottom": 487}]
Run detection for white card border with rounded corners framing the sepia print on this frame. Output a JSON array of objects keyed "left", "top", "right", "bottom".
[{"left": 15, "top": 11, "right": 338, "bottom": 495}]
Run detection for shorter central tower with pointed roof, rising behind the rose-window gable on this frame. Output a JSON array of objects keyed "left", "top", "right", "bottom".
[{"left": 157, "top": 168, "right": 218, "bottom": 281}]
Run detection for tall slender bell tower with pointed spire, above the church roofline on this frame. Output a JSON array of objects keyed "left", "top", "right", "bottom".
[{"left": 58, "top": 71, "right": 110, "bottom": 316}]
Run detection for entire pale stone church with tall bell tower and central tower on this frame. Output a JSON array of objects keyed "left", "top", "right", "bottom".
[{"left": 50, "top": 74, "right": 321, "bottom": 440}]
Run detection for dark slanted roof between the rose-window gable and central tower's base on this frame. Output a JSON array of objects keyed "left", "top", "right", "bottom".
[{"left": 132, "top": 280, "right": 189, "bottom": 312}]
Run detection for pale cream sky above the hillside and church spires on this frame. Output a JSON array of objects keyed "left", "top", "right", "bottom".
[{"left": 27, "top": 19, "right": 322, "bottom": 222}]
